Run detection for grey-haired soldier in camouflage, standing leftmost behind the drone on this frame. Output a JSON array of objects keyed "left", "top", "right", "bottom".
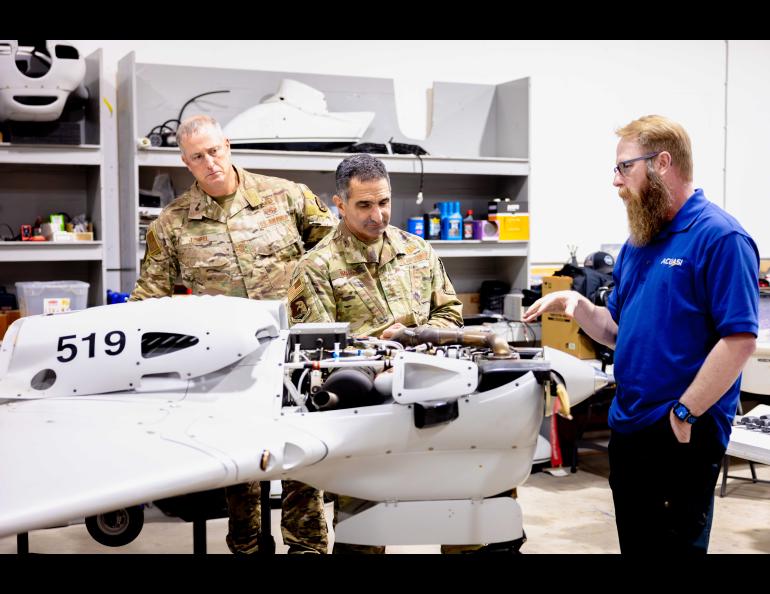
[{"left": 130, "top": 116, "right": 338, "bottom": 554}]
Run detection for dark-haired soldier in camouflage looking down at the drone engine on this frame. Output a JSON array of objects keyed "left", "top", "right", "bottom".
[{"left": 289, "top": 154, "right": 463, "bottom": 554}]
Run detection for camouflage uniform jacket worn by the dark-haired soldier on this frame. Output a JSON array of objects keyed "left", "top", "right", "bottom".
[{"left": 289, "top": 221, "right": 463, "bottom": 336}]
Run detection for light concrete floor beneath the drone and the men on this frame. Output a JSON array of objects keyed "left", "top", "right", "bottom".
[{"left": 0, "top": 450, "right": 770, "bottom": 554}]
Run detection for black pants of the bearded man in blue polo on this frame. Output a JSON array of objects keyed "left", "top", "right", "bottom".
[{"left": 609, "top": 413, "right": 725, "bottom": 555}]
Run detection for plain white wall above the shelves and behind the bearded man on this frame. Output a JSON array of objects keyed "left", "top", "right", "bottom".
[{"left": 75, "top": 40, "right": 770, "bottom": 263}]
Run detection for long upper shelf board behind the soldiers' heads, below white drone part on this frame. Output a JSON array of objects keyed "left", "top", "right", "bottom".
[{"left": 136, "top": 147, "right": 529, "bottom": 176}]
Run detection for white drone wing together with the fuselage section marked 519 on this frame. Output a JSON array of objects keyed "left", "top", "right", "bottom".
[{"left": 0, "top": 297, "right": 326, "bottom": 536}]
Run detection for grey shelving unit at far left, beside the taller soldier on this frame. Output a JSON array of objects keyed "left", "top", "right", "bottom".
[{"left": 0, "top": 50, "right": 111, "bottom": 307}]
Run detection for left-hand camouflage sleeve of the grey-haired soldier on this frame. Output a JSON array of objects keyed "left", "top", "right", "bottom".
[{"left": 128, "top": 220, "right": 179, "bottom": 301}]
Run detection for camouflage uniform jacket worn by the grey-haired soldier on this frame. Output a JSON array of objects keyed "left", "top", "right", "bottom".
[{"left": 130, "top": 167, "right": 338, "bottom": 301}]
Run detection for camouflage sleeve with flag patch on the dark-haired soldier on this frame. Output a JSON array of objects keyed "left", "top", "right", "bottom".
[{"left": 287, "top": 254, "right": 337, "bottom": 325}]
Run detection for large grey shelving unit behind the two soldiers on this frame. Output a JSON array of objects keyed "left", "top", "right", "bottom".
[{"left": 117, "top": 53, "right": 530, "bottom": 292}]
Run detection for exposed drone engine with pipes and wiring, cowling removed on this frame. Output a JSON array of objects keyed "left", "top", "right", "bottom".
[{"left": 284, "top": 323, "right": 550, "bottom": 411}]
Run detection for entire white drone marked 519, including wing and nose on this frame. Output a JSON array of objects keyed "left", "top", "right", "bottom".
[{"left": 0, "top": 296, "right": 607, "bottom": 545}]
